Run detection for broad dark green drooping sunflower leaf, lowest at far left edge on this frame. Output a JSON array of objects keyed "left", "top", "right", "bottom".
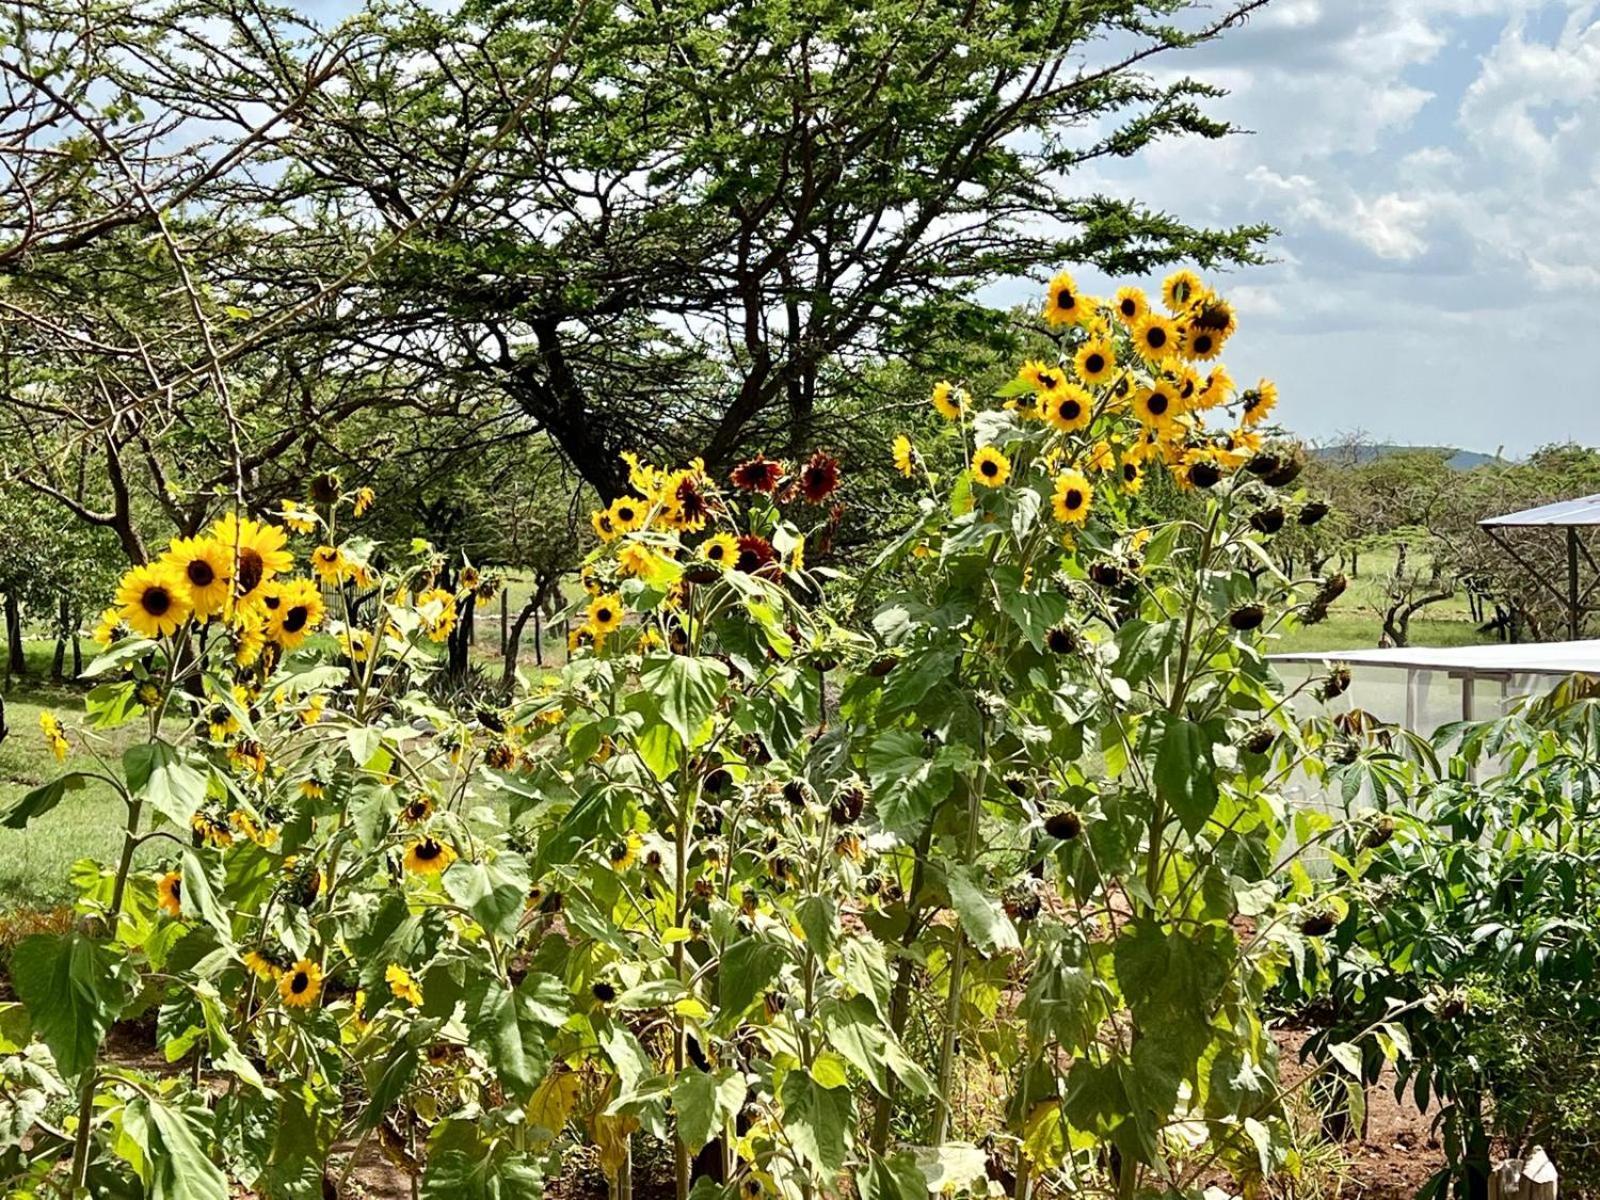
[{"left": 11, "top": 933, "right": 128, "bottom": 1078}]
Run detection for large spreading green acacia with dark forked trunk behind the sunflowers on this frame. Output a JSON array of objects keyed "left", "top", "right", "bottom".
[{"left": 219, "top": 0, "right": 1266, "bottom": 498}]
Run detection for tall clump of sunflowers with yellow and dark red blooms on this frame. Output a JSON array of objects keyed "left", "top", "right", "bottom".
[{"left": 0, "top": 270, "right": 1395, "bottom": 1200}]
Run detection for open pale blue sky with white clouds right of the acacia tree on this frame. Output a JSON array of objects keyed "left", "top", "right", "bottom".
[{"left": 1002, "top": 0, "right": 1600, "bottom": 458}]
